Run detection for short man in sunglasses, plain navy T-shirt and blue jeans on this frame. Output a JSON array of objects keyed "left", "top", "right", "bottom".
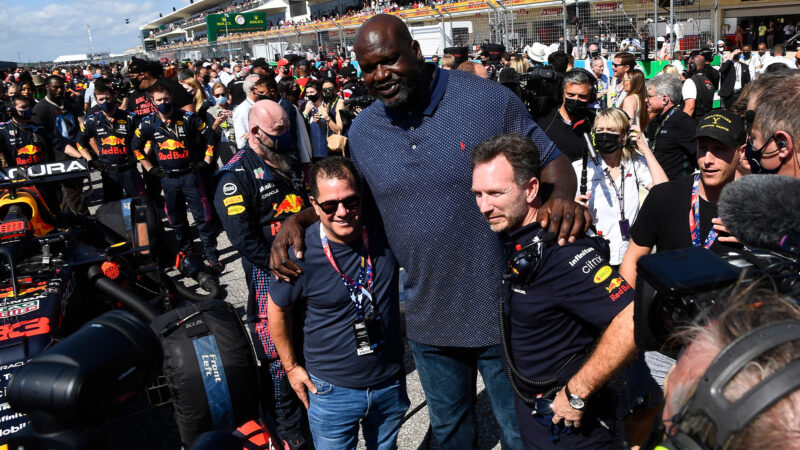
[{"left": 268, "top": 157, "right": 410, "bottom": 449}]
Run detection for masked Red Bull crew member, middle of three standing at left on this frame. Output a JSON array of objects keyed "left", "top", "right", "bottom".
[{"left": 78, "top": 83, "right": 144, "bottom": 203}]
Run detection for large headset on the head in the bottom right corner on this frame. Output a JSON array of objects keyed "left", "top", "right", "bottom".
[{"left": 656, "top": 320, "right": 800, "bottom": 450}]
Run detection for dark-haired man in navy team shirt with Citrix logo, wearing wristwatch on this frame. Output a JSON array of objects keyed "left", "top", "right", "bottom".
[{"left": 470, "top": 134, "right": 635, "bottom": 449}]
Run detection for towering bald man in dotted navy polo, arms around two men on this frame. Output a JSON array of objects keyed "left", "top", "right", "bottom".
[{"left": 271, "top": 14, "right": 588, "bottom": 450}]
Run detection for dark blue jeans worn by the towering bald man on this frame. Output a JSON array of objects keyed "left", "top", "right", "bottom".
[{"left": 408, "top": 339, "right": 522, "bottom": 450}]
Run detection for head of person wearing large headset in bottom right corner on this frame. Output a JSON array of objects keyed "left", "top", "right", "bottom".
[{"left": 662, "top": 289, "right": 800, "bottom": 449}]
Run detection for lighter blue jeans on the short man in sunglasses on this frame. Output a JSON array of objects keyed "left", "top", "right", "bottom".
[{"left": 308, "top": 374, "right": 411, "bottom": 450}]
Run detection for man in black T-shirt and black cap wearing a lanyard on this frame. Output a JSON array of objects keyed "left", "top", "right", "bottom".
[{"left": 619, "top": 110, "right": 745, "bottom": 286}]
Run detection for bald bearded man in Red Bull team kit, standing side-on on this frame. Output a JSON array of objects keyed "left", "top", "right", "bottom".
[{"left": 214, "top": 100, "right": 310, "bottom": 449}]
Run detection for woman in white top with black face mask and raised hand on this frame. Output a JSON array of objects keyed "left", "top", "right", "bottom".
[{"left": 572, "top": 108, "right": 667, "bottom": 267}]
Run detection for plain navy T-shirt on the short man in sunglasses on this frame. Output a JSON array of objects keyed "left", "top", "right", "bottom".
[{"left": 269, "top": 221, "right": 403, "bottom": 389}]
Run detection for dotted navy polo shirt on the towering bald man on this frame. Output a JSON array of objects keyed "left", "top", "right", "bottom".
[{"left": 349, "top": 63, "right": 560, "bottom": 347}]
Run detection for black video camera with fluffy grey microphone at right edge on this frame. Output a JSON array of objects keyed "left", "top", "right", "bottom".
[{"left": 634, "top": 175, "right": 800, "bottom": 357}]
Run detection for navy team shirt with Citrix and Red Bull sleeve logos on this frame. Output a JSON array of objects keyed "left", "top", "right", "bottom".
[{"left": 505, "top": 223, "right": 633, "bottom": 384}]
